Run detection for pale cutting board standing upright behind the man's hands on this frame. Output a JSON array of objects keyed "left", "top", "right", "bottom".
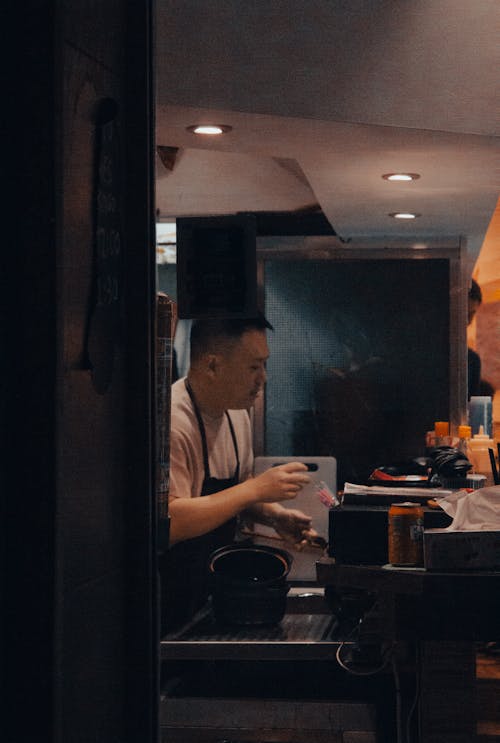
[{"left": 250, "top": 456, "right": 337, "bottom": 584}]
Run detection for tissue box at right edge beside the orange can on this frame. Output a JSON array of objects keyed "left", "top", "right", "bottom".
[{"left": 424, "top": 529, "right": 500, "bottom": 570}]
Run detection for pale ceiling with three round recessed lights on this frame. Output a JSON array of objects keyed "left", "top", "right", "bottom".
[{"left": 155, "top": 0, "right": 500, "bottom": 265}]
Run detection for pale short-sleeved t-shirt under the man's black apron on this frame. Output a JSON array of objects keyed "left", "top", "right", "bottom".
[{"left": 169, "top": 378, "right": 253, "bottom": 498}]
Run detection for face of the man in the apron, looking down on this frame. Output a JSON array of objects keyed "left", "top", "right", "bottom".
[{"left": 218, "top": 330, "right": 269, "bottom": 410}]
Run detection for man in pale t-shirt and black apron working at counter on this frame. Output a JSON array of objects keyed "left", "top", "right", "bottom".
[{"left": 162, "top": 317, "right": 313, "bottom": 629}]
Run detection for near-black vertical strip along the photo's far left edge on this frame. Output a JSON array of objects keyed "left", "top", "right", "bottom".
[{"left": 0, "top": 7, "right": 56, "bottom": 743}]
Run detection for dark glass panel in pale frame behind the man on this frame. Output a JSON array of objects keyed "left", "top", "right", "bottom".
[{"left": 265, "top": 258, "right": 450, "bottom": 486}]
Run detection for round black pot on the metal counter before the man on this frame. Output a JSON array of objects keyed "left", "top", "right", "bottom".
[{"left": 209, "top": 544, "right": 293, "bottom": 625}]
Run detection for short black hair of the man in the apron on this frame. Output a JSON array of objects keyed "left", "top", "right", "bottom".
[{"left": 190, "top": 314, "right": 274, "bottom": 361}]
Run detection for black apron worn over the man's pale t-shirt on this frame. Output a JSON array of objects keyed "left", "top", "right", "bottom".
[{"left": 159, "top": 379, "right": 240, "bottom": 634}]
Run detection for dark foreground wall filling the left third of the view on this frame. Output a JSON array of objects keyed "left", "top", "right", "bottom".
[{"left": 2, "top": 0, "right": 158, "bottom": 743}]
